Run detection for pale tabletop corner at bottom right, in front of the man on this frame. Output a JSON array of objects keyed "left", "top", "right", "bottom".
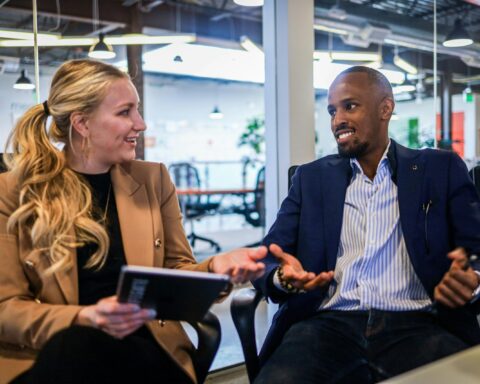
[{"left": 382, "top": 346, "right": 480, "bottom": 384}]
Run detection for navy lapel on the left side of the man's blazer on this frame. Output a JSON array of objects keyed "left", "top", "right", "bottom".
[{"left": 322, "top": 157, "right": 352, "bottom": 270}]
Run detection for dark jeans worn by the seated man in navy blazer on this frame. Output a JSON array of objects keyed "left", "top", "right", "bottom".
[{"left": 255, "top": 310, "right": 468, "bottom": 384}]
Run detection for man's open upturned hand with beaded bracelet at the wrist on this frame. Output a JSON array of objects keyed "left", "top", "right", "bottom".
[{"left": 269, "top": 244, "right": 333, "bottom": 291}]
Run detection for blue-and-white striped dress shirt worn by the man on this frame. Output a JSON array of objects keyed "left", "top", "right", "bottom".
[{"left": 320, "top": 144, "right": 432, "bottom": 311}]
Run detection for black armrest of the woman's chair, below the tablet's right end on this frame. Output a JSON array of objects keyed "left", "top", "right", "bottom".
[{"left": 189, "top": 312, "right": 222, "bottom": 383}]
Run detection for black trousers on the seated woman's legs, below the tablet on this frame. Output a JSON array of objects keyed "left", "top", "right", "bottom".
[{"left": 11, "top": 326, "right": 192, "bottom": 384}]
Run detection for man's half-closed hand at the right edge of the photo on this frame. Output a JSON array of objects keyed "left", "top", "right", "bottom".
[{"left": 434, "top": 248, "right": 480, "bottom": 308}]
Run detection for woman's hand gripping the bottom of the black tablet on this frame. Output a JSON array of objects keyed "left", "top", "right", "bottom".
[{"left": 75, "top": 296, "right": 156, "bottom": 339}]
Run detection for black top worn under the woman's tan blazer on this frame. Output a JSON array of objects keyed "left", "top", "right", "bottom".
[{"left": 77, "top": 173, "right": 126, "bottom": 305}]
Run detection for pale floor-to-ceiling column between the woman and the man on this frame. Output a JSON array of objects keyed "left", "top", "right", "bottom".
[{"left": 263, "top": 0, "right": 315, "bottom": 228}]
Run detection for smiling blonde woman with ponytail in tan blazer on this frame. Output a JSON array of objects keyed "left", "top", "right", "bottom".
[{"left": 0, "top": 60, "right": 266, "bottom": 383}]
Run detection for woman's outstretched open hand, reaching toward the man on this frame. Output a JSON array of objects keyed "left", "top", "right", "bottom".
[{"left": 210, "top": 246, "right": 267, "bottom": 284}]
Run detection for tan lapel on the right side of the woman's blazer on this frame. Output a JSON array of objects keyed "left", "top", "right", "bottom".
[{"left": 111, "top": 165, "right": 154, "bottom": 266}]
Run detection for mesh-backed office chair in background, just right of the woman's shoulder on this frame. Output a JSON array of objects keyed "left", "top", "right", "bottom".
[{"left": 168, "top": 163, "right": 221, "bottom": 252}]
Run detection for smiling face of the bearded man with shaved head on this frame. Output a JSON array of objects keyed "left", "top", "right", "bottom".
[{"left": 327, "top": 72, "right": 388, "bottom": 159}]
